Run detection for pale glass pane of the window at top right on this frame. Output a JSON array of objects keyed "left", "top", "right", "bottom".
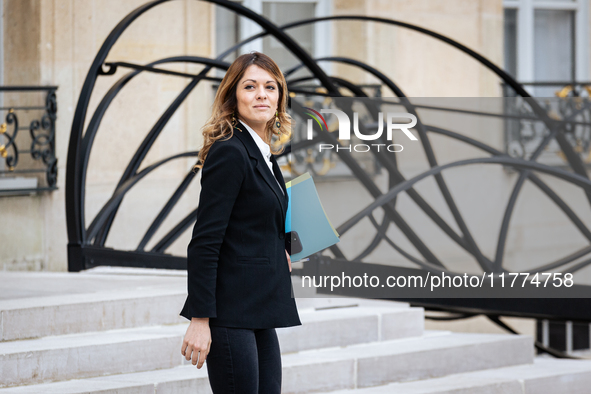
[{"left": 534, "top": 10, "right": 575, "bottom": 97}]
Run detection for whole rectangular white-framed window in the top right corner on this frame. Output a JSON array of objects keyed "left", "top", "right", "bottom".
[{"left": 504, "top": 0, "right": 591, "bottom": 97}]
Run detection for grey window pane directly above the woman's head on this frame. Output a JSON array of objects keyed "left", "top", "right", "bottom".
[{"left": 263, "top": 2, "right": 316, "bottom": 77}]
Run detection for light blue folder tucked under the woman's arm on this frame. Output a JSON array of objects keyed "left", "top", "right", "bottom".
[{"left": 285, "top": 172, "right": 339, "bottom": 262}]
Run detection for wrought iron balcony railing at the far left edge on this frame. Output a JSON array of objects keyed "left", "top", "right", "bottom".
[{"left": 0, "top": 86, "right": 57, "bottom": 196}]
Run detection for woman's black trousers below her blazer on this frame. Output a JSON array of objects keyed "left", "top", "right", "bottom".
[{"left": 205, "top": 326, "right": 281, "bottom": 394}]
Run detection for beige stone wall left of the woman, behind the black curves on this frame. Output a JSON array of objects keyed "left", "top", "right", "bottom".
[{"left": 0, "top": 0, "right": 214, "bottom": 271}]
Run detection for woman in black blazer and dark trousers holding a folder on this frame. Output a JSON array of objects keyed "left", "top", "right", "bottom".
[{"left": 181, "top": 52, "right": 301, "bottom": 394}]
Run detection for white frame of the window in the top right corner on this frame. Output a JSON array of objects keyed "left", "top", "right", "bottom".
[{"left": 503, "top": 0, "right": 590, "bottom": 85}]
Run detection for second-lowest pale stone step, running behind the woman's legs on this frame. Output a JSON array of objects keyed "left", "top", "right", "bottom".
[{"left": 0, "top": 331, "right": 533, "bottom": 394}]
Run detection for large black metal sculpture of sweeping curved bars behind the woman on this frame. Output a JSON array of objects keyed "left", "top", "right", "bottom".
[{"left": 66, "top": 0, "right": 591, "bottom": 348}]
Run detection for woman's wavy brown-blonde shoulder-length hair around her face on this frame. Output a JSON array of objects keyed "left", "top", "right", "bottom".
[{"left": 193, "top": 52, "right": 291, "bottom": 170}]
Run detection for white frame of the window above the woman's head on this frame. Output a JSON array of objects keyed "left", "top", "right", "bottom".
[{"left": 240, "top": 0, "right": 332, "bottom": 74}]
